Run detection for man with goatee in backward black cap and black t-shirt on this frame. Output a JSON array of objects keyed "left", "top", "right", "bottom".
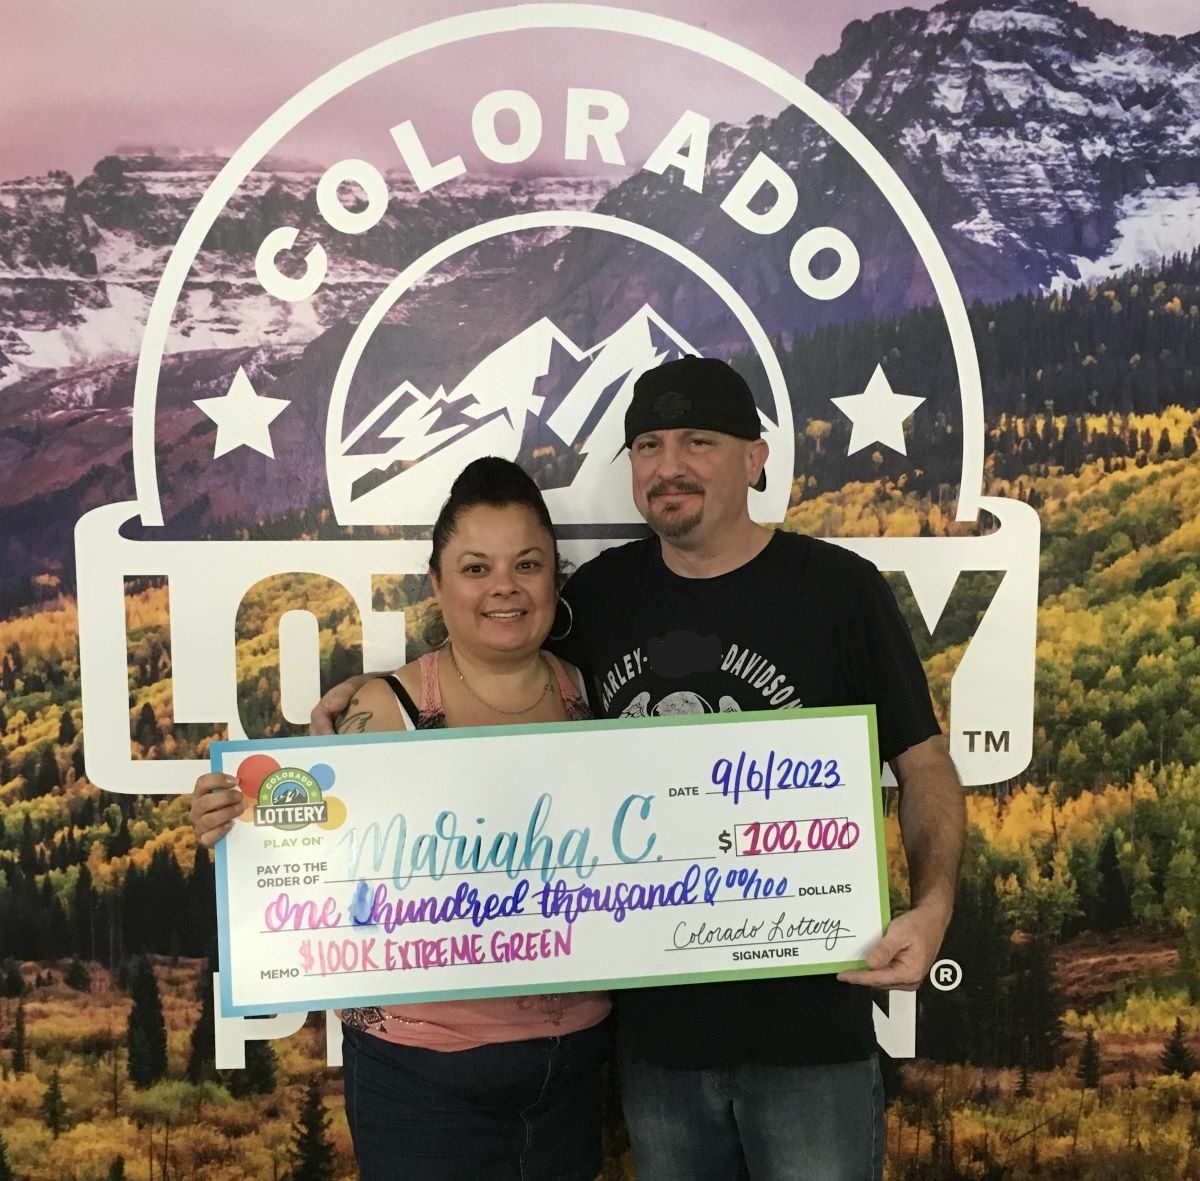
[{"left": 314, "top": 356, "right": 965, "bottom": 1181}]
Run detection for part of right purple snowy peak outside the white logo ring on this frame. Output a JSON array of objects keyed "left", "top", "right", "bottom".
[{"left": 808, "top": 0, "right": 1200, "bottom": 299}]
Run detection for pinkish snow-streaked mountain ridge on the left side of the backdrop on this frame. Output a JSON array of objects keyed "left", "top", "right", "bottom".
[{"left": 0, "top": 152, "right": 607, "bottom": 389}]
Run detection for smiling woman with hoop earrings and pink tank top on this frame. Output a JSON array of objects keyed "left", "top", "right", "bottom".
[{"left": 191, "top": 457, "right": 608, "bottom": 1181}]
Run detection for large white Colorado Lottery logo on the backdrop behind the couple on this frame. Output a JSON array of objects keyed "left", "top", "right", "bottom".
[{"left": 77, "top": 4, "right": 1039, "bottom": 793}]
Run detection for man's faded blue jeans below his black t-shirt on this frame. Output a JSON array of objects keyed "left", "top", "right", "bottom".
[{"left": 619, "top": 1033, "right": 883, "bottom": 1181}]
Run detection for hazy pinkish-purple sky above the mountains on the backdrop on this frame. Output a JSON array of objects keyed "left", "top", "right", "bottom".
[{"left": 0, "top": 0, "right": 1200, "bottom": 179}]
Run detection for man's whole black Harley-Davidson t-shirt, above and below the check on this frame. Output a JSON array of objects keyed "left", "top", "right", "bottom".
[{"left": 554, "top": 533, "right": 938, "bottom": 1069}]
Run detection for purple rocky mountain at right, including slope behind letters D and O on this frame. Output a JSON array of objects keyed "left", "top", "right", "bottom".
[{"left": 453, "top": 0, "right": 1200, "bottom": 348}]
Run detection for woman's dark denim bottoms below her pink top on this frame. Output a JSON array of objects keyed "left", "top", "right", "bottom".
[{"left": 342, "top": 1021, "right": 610, "bottom": 1181}]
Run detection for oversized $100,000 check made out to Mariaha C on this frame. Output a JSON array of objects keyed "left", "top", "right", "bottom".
[{"left": 212, "top": 707, "right": 888, "bottom": 1015}]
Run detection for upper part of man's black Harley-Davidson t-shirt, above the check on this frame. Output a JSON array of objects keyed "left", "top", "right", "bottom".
[{"left": 554, "top": 532, "right": 938, "bottom": 759}]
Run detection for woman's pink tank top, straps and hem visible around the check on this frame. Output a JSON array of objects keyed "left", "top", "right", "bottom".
[{"left": 342, "top": 652, "right": 610, "bottom": 1050}]
